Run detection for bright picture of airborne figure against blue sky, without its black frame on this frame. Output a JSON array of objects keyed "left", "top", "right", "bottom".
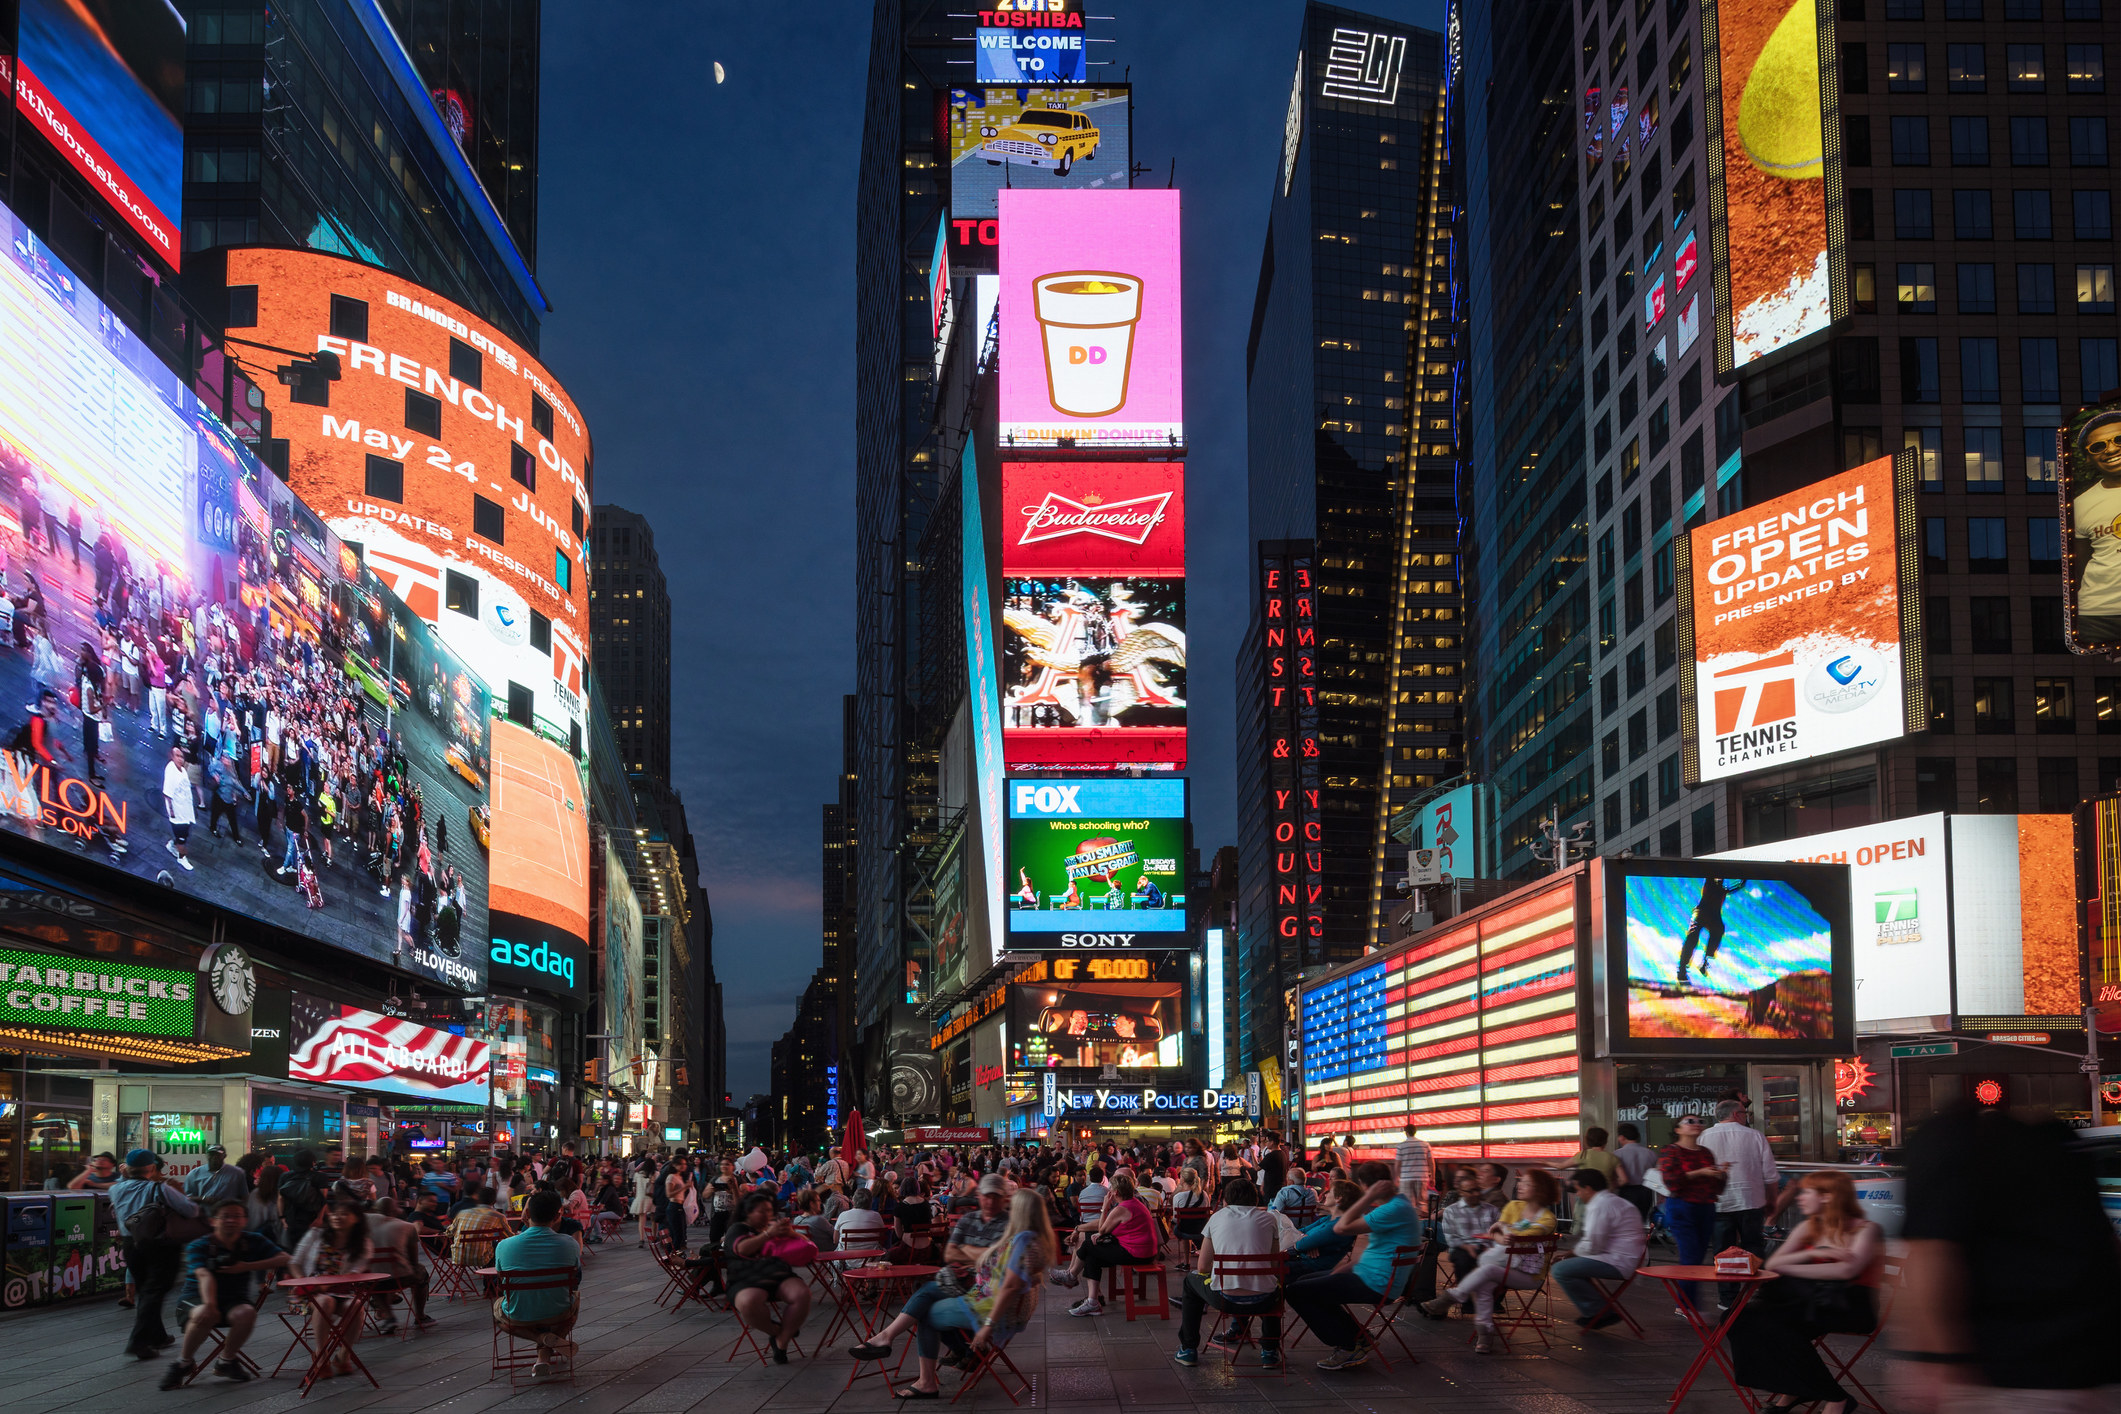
[{"left": 1627, "top": 865, "right": 1835, "bottom": 1041}]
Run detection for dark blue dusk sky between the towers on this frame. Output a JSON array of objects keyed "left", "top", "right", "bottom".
[{"left": 537, "top": 0, "right": 1442, "bottom": 1100}]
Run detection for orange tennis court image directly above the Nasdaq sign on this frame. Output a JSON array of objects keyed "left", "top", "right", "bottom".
[{"left": 488, "top": 721, "right": 590, "bottom": 939}]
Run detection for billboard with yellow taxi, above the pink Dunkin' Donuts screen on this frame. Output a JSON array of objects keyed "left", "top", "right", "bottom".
[{"left": 948, "top": 83, "right": 1133, "bottom": 220}]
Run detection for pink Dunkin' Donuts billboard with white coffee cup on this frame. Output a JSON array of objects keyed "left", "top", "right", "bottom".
[{"left": 999, "top": 191, "right": 1186, "bottom": 452}]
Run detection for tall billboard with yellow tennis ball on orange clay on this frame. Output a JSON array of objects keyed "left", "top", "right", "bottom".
[{"left": 1701, "top": 0, "right": 1839, "bottom": 373}]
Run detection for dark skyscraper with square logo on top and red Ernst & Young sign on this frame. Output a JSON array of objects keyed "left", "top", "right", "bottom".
[{"left": 1239, "top": 4, "right": 1463, "bottom": 1068}]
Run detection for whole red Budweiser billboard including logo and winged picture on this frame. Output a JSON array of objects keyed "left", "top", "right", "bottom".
[{"left": 1001, "top": 462, "right": 1186, "bottom": 770}]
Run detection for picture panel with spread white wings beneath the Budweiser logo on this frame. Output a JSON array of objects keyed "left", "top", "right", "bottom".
[{"left": 1001, "top": 577, "right": 1186, "bottom": 727}]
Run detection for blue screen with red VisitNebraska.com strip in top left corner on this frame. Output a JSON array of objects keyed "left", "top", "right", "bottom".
[{"left": 15, "top": 0, "right": 184, "bottom": 269}]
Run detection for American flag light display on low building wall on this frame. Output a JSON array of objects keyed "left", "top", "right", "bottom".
[{"left": 1302, "top": 880, "right": 1580, "bottom": 1160}]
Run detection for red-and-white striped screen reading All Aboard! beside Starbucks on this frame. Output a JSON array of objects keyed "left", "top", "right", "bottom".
[{"left": 286, "top": 992, "right": 490, "bottom": 1104}]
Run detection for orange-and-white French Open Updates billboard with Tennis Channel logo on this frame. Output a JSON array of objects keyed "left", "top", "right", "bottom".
[{"left": 1678, "top": 452, "right": 1928, "bottom": 782}]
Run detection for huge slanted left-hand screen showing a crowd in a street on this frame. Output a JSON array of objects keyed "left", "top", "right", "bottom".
[{"left": 0, "top": 212, "right": 490, "bottom": 992}]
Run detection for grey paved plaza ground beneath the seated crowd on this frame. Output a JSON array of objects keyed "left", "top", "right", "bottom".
[{"left": 0, "top": 1244, "right": 1894, "bottom": 1414}]
